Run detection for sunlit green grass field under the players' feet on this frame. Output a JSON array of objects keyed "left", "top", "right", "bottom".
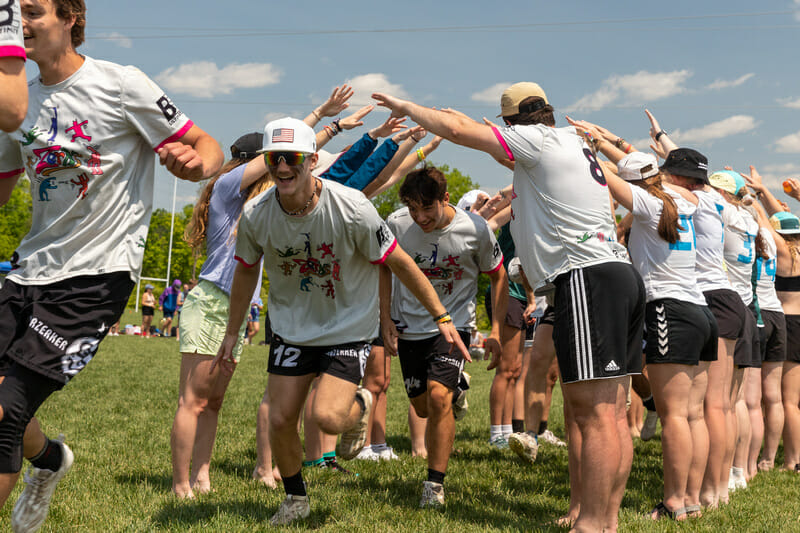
[{"left": 0, "top": 308, "right": 800, "bottom": 533}]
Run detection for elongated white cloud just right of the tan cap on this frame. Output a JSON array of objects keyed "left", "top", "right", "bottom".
[{"left": 566, "top": 70, "right": 692, "bottom": 112}]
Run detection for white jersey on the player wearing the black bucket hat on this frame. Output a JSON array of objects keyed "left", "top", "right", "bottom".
[{"left": 693, "top": 190, "right": 731, "bottom": 292}]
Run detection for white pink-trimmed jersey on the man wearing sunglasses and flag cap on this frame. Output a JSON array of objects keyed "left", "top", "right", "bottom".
[{"left": 236, "top": 179, "right": 397, "bottom": 346}]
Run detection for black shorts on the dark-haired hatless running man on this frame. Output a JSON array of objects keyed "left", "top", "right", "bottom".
[{"left": 397, "top": 331, "right": 470, "bottom": 398}]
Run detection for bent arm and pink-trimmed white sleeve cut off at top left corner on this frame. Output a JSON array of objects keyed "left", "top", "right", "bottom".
[{"left": 0, "top": 0, "right": 28, "bottom": 132}]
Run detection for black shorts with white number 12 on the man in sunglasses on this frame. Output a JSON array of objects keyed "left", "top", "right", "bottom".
[{"left": 267, "top": 334, "right": 372, "bottom": 385}]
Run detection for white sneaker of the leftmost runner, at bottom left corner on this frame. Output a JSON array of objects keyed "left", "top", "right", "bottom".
[{"left": 11, "top": 435, "right": 75, "bottom": 533}]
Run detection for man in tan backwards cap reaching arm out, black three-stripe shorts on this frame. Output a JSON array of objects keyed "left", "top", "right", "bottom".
[{"left": 373, "top": 83, "right": 645, "bottom": 531}]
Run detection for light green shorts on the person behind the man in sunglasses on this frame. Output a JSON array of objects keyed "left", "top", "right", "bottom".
[{"left": 180, "top": 279, "right": 247, "bottom": 363}]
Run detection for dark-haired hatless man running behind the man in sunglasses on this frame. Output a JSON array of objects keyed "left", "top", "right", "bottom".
[{"left": 381, "top": 167, "right": 508, "bottom": 507}]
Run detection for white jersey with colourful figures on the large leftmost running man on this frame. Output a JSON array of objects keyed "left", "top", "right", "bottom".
[{"left": 0, "top": 57, "right": 193, "bottom": 285}]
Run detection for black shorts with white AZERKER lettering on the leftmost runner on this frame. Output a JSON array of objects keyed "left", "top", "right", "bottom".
[{"left": 0, "top": 272, "right": 134, "bottom": 386}]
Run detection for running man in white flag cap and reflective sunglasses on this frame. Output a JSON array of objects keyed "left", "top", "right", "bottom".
[{"left": 214, "top": 118, "right": 469, "bottom": 524}]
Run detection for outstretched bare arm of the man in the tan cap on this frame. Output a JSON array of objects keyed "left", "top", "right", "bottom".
[{"left": 372, "top": 93, "right": 506, "bottom": 160}]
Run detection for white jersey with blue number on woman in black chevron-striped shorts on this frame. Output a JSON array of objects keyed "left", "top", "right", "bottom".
[{"left": 628, "top": 184, "right": 706, "bottom": 305}]
